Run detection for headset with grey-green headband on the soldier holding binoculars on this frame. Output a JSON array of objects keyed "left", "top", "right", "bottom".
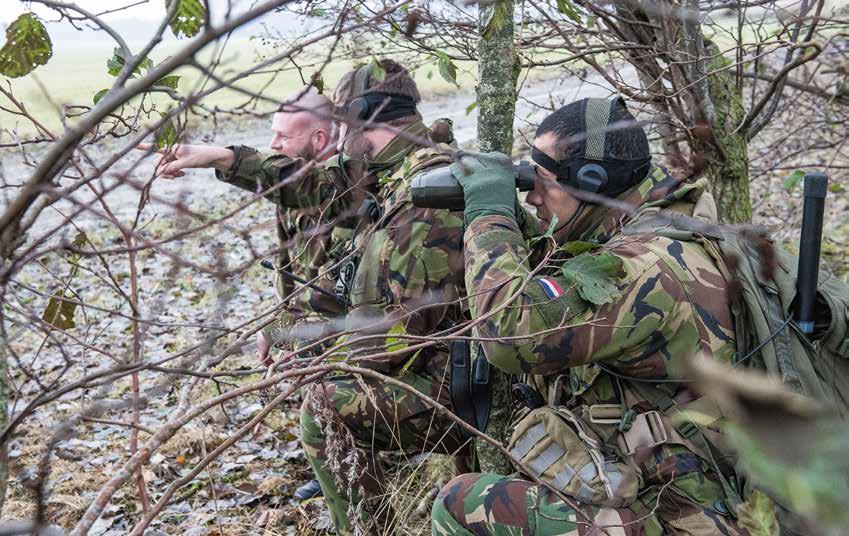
[{"left": 531, "top": 97, "right": 651, "bottom": 195}]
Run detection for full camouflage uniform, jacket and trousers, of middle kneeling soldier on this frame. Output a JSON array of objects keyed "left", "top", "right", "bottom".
[{"left": 301, "top": 122, "right": 464, "bottom": 534}]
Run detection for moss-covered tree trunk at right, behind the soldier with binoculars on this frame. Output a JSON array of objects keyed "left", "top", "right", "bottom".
[{"left": 705, "top": 43, "right": 752, "bottom": 223}]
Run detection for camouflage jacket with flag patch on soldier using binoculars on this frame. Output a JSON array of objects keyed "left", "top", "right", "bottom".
[{"left": 435, "top": 168, "right": 736, "bottom": 534}]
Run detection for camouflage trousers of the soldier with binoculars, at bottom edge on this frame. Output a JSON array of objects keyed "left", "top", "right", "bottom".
[{"left": 432, "top": 473, "right": 746, "bottom": 536}]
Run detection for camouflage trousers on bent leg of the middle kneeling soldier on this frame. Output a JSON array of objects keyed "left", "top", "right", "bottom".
[{"left": 301, "top": 366, "right": 463, "bottom": 535}]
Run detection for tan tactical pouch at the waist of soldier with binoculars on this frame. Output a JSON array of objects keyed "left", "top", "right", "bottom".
[{"left": 507, "top": 406, "right": 639, "bottom": 508}]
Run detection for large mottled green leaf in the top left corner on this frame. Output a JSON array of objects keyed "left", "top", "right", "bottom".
[{"left": 0, "top": 13, "right": 53, "bottom": 78}]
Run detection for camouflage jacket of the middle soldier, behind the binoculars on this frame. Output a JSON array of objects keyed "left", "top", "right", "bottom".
[{"left": 332, "top": 130, "right": 465, "bottom": 377}]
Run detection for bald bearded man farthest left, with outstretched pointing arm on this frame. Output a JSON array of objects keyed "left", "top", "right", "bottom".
[{"left": 140, "top": 89, "right": 357, "bottom": 500}]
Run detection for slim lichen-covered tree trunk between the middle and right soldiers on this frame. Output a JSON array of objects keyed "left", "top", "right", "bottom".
[{"left": 475, "top": 0, "right": 519, "bottom": 474}]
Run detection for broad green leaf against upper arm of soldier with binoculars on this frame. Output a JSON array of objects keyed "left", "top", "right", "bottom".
[{"left": 562, "top": 252, "right": 624, "bottom": 305}]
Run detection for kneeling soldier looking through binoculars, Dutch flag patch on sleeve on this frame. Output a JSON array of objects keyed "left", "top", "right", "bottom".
[{"left": 432, "top": 99, "right": 741, "bottom": 535}]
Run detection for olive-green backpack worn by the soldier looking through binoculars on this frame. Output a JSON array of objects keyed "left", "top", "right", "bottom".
[{"left": 623, "top": 212, "right": 849, "bottom": 412}]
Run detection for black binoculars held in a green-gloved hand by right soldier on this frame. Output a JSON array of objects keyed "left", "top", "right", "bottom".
[{"left": 410, "top": 160, "right": 536, "bottom": 210}]
